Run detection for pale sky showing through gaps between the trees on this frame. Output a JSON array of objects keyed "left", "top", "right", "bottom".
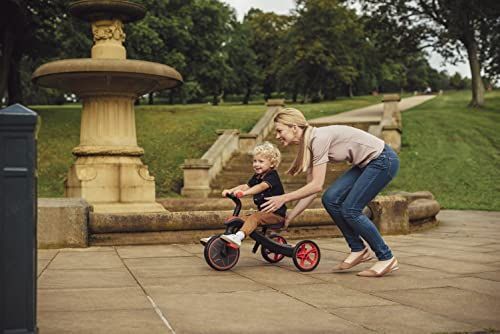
[{"left": 223, "top": 0, "right": 471, "bottom": 78}]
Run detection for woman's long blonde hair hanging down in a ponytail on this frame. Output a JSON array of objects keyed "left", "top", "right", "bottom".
[{"left": 274, "top": 108, "right": 312, "bottom": 175}]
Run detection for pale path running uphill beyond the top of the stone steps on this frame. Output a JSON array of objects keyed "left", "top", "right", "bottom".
[{"left": 309, "top": 95, "right": 436, "bottom": 124}]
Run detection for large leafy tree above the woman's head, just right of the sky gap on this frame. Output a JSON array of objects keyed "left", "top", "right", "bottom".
[{"left": 278, "top": 0, "right": 364, "bottom": 102}]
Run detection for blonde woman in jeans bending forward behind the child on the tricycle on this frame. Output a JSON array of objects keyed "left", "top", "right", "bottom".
[{"left": 262, "top": 108, "right": 399, "bottom": 277}]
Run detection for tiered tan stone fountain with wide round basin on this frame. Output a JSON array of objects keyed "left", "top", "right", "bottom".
[{"left": 32, "top": 0, "right": 182, "bottom": 213}]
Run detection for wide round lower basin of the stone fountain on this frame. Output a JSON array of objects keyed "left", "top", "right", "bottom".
[{"left": 32, "top": 58, "right": 183, "bottom": 96}]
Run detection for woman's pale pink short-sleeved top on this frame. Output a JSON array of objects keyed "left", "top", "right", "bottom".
[{"left": 310, "top": 125, "right": 385, "bottom": 167}]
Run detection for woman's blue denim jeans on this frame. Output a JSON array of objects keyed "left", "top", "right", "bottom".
[{"left": 322, "top": 145, "right": 399, "bottom": 261}]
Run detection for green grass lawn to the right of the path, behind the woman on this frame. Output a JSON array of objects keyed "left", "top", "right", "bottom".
[{"left": 387, "top": 91, "right": 500, "bottom": 210}]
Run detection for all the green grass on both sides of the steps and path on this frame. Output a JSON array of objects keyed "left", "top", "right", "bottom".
[{"left": 32, "top": 91, "right": 500, "bottom": 210}]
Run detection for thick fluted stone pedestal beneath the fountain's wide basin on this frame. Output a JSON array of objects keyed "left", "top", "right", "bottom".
[{"left": 66, "top": 94, "right": 164, "bottom": 212}]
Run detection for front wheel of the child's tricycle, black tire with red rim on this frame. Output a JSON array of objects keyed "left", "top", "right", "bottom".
[{"left": 203, "top": 237, "right": 240, "bottom": 271}]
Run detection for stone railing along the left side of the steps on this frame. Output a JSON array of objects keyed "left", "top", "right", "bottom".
[{"left": 181, "top": 100, "right": 285, "bottom": 198}]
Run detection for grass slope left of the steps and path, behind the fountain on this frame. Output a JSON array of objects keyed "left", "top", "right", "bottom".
[{"left": 31, "top": 96, "right": 380, "bottom": 197}]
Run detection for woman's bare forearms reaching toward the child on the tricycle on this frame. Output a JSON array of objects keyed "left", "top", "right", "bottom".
[{"left": 261, "top": 163, "right": 327, "bottom": 216}]
